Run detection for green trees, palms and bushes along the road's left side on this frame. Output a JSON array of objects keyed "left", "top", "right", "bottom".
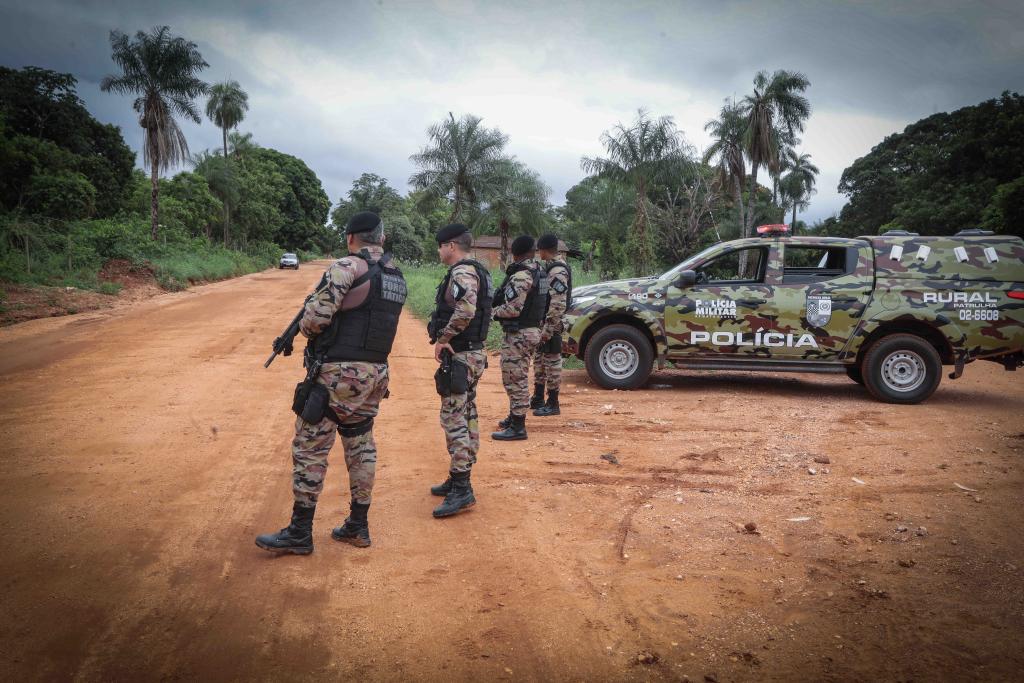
[{"left": 0, "top": 27, "right": 327, "bottom": 307}]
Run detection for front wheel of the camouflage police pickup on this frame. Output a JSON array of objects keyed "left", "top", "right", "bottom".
[{"left": 585, "top": 325, "right": 654, "bottom": 389}]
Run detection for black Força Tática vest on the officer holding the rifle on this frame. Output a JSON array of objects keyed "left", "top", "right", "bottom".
[{"left": 314, "top": 254, "right": 409, "bottom": 362}]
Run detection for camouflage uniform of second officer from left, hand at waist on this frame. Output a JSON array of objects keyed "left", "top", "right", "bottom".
[{"left": 437, "top": 263, "right": 487, "bottom": 472}]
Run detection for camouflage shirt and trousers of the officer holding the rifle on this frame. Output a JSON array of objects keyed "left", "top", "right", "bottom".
[{"left": 292, "top": 247, "right": 388, "bottom": 507}]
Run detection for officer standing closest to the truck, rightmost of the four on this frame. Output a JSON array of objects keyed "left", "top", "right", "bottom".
[{"left": 529, "top": 232, "right": 572, "bottom": 418}]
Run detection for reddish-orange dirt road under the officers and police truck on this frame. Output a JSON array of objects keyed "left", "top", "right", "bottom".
[{"left": 0, "top": 260, "right": 1024, "bottom": 681}]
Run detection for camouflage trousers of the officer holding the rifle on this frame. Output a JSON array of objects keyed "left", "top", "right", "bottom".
[{"left": 292, "top": 362, "right": 388, "bottom": 507}]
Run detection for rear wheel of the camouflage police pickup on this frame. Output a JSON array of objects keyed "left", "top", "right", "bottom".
[{"left": 860, "top": 334, "right": 942, "bottom": 403}]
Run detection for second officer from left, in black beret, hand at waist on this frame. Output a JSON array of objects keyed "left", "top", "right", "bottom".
[{"left": 428, "top": 223, "right": 494, "bottom": 517}]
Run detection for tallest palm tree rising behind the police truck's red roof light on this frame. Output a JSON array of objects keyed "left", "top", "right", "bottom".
[{"left": 742, "top": 70, "right": 811, "bottom": 238}]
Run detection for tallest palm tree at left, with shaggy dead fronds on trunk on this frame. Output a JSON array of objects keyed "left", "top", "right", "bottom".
[{"left": 99, "top": 26, "right": 210, "bottom": 240}]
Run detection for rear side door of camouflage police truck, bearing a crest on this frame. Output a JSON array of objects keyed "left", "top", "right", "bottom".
[{"left": 774, "top": 240, "right": 873, "bottom": 360}]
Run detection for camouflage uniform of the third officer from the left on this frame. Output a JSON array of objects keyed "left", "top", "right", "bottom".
[{"left": 493, "top": 259, "right": 542, "bottom": 417}]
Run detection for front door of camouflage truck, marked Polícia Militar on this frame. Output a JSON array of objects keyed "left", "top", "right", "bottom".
[{"left": 665, "top": 240, "right": 776, "bottom": 358}]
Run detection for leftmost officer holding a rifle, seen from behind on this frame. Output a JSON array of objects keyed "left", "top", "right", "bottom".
[{"left": 256, "top": 211, "right": 407, "bottom": 555}]
